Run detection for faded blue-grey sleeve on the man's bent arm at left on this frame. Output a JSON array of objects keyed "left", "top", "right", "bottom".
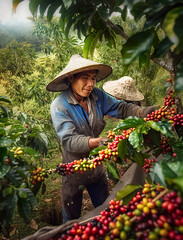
[{"left": 51, "top": 104, "right": 91, "bottom": 153}]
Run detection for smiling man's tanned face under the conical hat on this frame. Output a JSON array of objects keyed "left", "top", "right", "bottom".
[{"left": 69, "top": 70, "right": 97, "bottom": 100}]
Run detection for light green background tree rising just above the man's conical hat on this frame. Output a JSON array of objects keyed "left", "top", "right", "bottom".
[{"left": 34, "top": 18, "right": 83, "bottom": 74}]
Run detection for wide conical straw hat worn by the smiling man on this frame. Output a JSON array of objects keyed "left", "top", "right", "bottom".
[{"left": 46, "top": 54, "right": 112, "bottom": 92}]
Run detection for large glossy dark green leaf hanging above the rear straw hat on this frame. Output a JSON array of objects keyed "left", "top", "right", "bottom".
[{"left": 121, "top": 29, "right": 156, "bottom": 65}]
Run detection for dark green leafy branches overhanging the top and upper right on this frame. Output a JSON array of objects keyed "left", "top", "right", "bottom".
[{"left": 13, "top": 0, "right": 183, "bottom": 109}]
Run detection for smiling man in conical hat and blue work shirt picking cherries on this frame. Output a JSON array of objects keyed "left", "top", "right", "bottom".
[{"left": 47, "top": 55, "right": 154, "bottom": 223}]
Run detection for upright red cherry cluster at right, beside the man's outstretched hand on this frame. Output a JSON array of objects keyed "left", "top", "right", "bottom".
[{"left": 144, "top": 90, "right": 176, "bottom": 122}]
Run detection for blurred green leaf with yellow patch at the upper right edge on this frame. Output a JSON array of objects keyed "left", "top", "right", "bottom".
[{"left": 163, "top": 7, "right": 183, "bottom": 45}]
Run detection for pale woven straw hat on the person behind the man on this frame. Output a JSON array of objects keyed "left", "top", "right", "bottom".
[{"left": 103, "top": 76, "right": 144, "bottom": 101}]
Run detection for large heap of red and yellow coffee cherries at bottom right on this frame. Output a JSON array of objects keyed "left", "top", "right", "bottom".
[{"left": 49, "top": 183, "right": 183, "bottom": 240}]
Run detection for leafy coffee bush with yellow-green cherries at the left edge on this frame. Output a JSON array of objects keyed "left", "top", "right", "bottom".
[{"left": 0, "top": 97, "right": 48, "bottom": 233}]
